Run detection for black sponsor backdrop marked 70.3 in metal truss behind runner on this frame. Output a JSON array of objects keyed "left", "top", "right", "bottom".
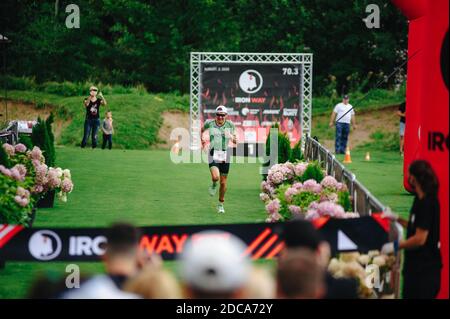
[{"left": 200, "top": 63, "right": 302, "bottom": 143}]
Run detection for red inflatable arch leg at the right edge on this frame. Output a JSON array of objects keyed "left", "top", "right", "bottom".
[{"left": 392, "top": 0, "right": 449, "bottom": 298}]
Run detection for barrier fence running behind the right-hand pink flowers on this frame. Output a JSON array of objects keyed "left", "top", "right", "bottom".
[{"left": 303, "top": 136, "right": 403, "bottom": 298}]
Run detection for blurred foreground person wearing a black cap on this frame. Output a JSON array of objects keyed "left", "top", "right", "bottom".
[{"left": 281, "top": 219, "right": 359, "bottom": 299}]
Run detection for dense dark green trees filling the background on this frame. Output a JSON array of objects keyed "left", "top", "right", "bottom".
[{"left": 0, "top": 0, "right": 407, "bottom": 97}]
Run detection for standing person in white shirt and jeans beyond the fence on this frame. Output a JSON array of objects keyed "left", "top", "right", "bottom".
[{"left": 330, "top": 95, "right": 356, "bottom": 154}]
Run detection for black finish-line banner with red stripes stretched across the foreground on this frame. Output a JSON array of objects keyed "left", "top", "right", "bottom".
[{"left": 0, "top": 217, "right": 388, "bottom": 262}]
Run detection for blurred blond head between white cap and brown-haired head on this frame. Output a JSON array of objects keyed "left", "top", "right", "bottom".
[{"left": 242, "top": 267, "right": 276, "bottom": 299}]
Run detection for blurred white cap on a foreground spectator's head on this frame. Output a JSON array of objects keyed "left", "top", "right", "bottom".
[{"left": 180, "top": 231, "right": 251, "bottom": 292}]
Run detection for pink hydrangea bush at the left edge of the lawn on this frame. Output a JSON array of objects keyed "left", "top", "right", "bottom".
[{"left": 0, "top": 143, "right": 73, "bottom": 225}]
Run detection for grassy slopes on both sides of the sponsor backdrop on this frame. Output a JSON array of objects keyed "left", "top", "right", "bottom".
[{"left": 3, "top": 88, "right": 404, "bottom": 149}]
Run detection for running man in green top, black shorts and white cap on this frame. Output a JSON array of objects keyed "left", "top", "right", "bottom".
[{"left": 201, "top": 105, "right": 237, "bottom": 213}]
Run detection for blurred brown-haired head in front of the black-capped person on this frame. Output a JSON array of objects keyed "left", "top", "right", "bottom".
[{"left": 277, "top": 248, "right": 326, "bottom": 299}]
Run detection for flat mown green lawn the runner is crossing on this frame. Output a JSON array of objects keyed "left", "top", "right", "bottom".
[{"left": 0, "top": 147, "right": 412, "bottom": 298}]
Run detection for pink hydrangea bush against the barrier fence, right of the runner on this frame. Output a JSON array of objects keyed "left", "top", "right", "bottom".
[{"left": 259, "top": 162, "right": 359, "bottom": 222}]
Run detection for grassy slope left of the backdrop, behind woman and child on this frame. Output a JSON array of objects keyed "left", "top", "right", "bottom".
[{"left": 3, "top": 91, "right": 189, "bottom": 149}]
